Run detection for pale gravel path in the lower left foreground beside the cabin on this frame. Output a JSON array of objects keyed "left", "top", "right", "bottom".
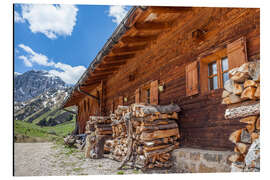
[{"left": 14, "top": 142, "right": 146, "bottom": 176}]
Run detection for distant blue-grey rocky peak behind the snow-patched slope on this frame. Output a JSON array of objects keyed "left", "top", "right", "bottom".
[{"left": 14, "top": 70, "right": 66, "bottom": 102}]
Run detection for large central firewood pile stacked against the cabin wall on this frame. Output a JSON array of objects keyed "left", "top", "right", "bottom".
[{"left": 109, "top": 104, "right": 180, "bottom": 169}]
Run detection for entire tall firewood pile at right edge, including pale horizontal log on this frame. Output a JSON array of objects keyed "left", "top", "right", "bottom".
[{"left": 222, "top": 61, "right": 260, "bottom": 172}]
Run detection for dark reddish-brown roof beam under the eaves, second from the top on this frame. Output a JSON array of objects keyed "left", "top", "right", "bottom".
[{"left": 134, "top": 22, "right": 172, "bottom": 31}]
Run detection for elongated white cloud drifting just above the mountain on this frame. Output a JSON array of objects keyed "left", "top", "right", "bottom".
[{"left": 19, "top": 44, "right": 86, "bottom": 84}]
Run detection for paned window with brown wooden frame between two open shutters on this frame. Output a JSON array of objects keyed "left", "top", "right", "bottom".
[{"left": 208, "top": 57, "right": 229, "bottom": 90}]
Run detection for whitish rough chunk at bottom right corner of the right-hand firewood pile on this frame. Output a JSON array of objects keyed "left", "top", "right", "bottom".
[{"left": 245, "top": 138, "right": 260, "bottom": 169}]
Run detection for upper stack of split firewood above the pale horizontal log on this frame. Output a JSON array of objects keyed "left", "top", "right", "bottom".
[{"left": 222, "top": 61, "right": 260, "bottom": 104}]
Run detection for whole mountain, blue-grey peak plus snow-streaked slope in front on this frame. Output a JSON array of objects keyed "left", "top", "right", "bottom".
[{"left": 14, "top": 71, "right": 77, "bottom": 126}]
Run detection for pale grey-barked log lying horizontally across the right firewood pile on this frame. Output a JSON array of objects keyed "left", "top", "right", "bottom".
[{"left": 225, "top": 103, "right": 260, "bottom": 119}]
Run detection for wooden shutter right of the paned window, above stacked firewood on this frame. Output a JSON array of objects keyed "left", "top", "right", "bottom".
[{"left": 227, "top": 37, "right": 247, "bottom": 69}]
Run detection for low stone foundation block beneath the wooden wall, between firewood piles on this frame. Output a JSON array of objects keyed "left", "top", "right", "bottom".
[{"left": 172, "top": 148, "right": 233, "bottom": 173}]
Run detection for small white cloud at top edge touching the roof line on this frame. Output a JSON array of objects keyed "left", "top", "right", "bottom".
[{"left": 109, "top": 6, "right": 128, "bottom": 24}]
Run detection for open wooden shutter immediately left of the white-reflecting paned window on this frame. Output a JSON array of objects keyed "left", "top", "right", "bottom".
[{"left": 186, "top": 61, "right": 199, "bottom": 96}]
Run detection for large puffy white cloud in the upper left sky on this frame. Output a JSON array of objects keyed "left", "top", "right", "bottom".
[{"left": 15, "top": 4, "right": 78, "bottom": 39}]
